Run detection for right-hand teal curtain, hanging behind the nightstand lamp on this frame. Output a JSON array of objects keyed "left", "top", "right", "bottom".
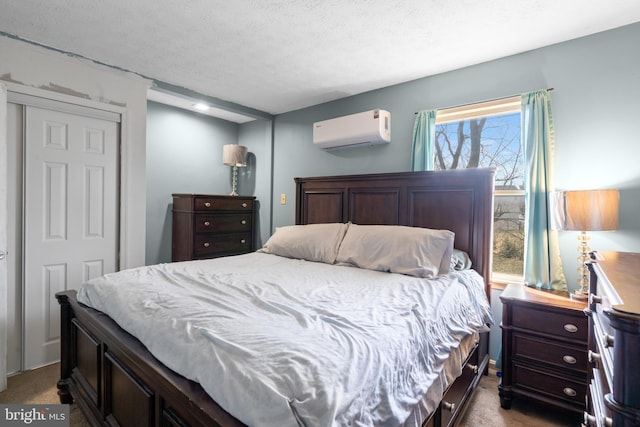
[{"left": 521, "top": 90, "right": 567, "bottom": 290}]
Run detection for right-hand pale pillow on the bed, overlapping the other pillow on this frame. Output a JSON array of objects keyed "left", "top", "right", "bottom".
[{"left": 336, "top": 224, "right": 455, "bottom": 277}]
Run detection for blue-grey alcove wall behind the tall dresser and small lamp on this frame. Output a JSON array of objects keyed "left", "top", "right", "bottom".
[{"left": 146, "top": 102, "right": 272, "bottom": 264}]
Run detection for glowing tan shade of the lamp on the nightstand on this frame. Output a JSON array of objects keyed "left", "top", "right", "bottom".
[{"left": 550, "top": 190, "right": 620, "bottom": 231}]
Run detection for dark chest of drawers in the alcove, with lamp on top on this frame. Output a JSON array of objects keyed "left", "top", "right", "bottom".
[{"left": 171, "top": 194, "right": 256, "bottom": 262}]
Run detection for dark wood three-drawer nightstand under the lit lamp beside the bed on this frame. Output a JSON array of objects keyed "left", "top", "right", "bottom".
[{"left": 498, "top": 284, "right": 589, "bottom": 417}]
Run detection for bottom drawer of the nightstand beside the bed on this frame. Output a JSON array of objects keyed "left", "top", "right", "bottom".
[{"left": 513, "top": 363, "right": 587, "bottom": 408}]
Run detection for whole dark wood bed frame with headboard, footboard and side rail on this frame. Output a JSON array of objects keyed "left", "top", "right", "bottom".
[{"left": 56, "top": 169, "right": 494, "bottom": 427}]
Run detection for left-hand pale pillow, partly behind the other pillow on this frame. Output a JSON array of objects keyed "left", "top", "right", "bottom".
[{"left": 258, "top": 223, "right": 349, "bottom": 264}]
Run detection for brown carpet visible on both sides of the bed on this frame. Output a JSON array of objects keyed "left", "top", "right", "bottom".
[{"left": 0, "top": 363, "right": 580, "bottom": 427}]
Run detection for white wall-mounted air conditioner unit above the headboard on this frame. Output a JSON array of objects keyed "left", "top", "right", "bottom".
[{"left": 313, "top": 109, "right": 391, "bottom": 150}]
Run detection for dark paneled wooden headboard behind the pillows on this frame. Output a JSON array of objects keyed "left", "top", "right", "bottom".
[{"left": 295, "top": 169, "right": 495, "bottom": 295}]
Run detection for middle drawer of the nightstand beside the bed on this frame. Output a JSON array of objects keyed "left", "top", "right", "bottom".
[{"left": 513, "top": 333, "right": 588, "bottom": 374}]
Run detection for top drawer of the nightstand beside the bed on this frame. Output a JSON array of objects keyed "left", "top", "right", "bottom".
[{"left": 512, "top": 305, "right": 589, "bottom": 342}]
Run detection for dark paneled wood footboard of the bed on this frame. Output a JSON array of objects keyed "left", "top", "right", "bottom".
[{"left": 56, "top": 291, "right": 244, "bottom": 427}]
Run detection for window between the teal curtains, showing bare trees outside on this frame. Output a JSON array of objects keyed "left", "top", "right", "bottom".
[{"left": 434, "top": 96, "right": 525, "bottom": 281}]
